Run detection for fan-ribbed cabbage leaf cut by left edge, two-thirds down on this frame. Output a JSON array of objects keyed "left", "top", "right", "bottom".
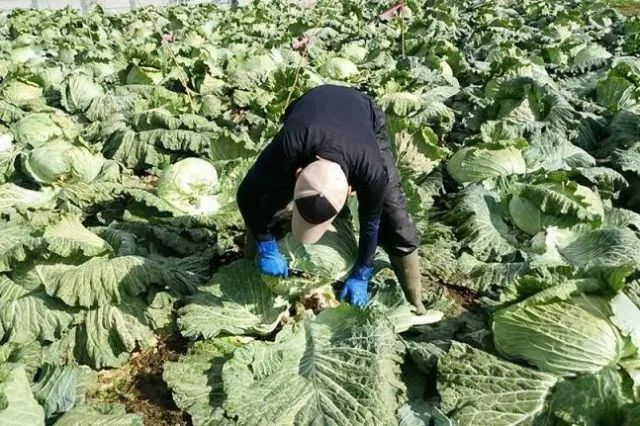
[{"left": 0, "top": 275, "right": 73, "bottom": 343}]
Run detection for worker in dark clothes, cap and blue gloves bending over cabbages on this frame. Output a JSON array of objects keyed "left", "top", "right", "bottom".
[{"left": 237, "top": 85, "right": 425, "bottom": 313}]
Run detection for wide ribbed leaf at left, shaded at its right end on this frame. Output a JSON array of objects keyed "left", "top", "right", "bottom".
[{"left": 38, "top": 256, "right": 169, "bottom": 308}]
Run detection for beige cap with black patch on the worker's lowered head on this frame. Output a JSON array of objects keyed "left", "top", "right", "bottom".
[{"left": 291, "top": 159, "right": 349, "bottom": 244}]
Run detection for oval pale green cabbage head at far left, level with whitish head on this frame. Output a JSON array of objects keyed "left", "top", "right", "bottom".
[{"left": 22, "top": 139, "right": 105, "bottom": 185}]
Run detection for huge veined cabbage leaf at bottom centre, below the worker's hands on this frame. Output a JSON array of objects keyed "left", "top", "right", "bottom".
[{"left": 222, "top": 306, "right": 402, "bottom": 425}]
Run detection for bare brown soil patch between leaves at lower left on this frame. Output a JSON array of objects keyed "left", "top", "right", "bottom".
[{"left": 90, "top": 335, "right": 191, "bottom": 426}]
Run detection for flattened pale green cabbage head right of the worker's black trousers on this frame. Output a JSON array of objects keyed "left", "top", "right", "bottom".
[{"left": 447, "top": 146, "right": 527, "bottom": 184}]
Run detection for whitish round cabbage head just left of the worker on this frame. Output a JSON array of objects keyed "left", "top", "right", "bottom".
[{"left": 158, "top": 158, "right": 220, "bottom": 215}]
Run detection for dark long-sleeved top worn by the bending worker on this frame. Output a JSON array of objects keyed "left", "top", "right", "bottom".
[{"left": 238, "top": 85, "right": 388, "bottom": 266}]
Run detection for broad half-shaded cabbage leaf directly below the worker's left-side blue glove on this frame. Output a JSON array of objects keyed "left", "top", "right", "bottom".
[{"left": 178, "top": 260, "right": 288, "bottom": 338}]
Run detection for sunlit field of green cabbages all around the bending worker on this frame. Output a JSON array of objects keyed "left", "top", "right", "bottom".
[{"left": 0, "top": 0, "right": 640, "bottom": 426}]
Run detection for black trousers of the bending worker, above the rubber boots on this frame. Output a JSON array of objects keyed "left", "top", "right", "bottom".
[{"left": 244, "top": 128, "right": 419, "bottom": 259}]
